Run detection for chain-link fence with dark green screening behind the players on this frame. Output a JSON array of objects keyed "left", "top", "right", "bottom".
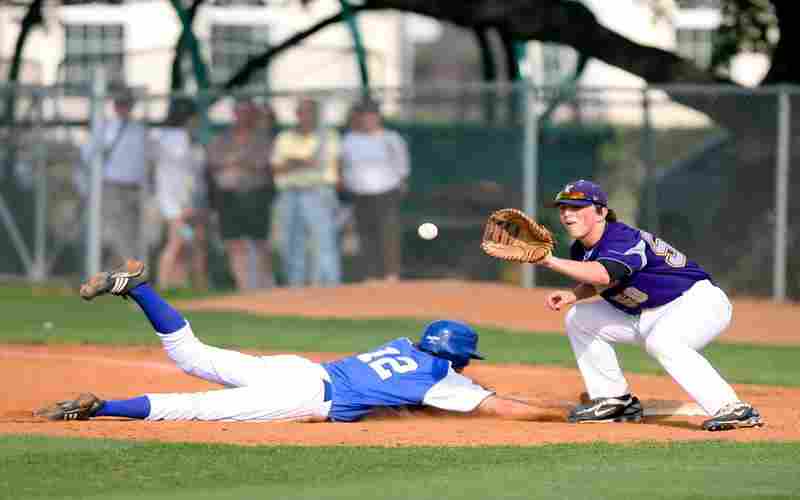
[{"left": 0, "top": 81, "right": 800, "bottom": 299}]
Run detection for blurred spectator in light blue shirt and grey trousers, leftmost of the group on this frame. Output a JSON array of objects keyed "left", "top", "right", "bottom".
[{"left": 78, "top": 89, "right": 149, "bottom": 267}]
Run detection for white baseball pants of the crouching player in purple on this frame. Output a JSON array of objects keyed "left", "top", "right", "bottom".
[{"left": 566, "top": 280, "right": 738, "bottom": 415}]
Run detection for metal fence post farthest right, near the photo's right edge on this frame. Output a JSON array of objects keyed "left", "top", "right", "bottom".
[{"left": 772, "top": 87, "right": 791, "bottom": 302}]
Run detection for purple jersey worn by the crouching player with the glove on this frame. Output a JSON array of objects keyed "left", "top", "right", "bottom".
[{"left": 570, "top": 222, "right": 711, "bottom": 314}]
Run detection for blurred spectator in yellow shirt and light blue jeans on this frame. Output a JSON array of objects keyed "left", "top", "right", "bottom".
[{"left": 272, "top": 99, "right": 341, "bottom": 286}]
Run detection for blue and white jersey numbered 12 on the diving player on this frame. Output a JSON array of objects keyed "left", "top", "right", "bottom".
[{"left": 322, "top": 338, "right": 493, "bottom": 422}]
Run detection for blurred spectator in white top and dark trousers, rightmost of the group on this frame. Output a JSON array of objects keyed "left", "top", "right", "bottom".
[{"left": 342, "top": 100, "right": 411, "bottom": 280}]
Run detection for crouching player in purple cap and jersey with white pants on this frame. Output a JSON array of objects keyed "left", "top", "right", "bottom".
[{"left": 539, "top": 180, "right": 763, "bottom": 431}]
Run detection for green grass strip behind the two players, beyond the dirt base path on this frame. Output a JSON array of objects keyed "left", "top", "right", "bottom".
[{"left": 0, "top": 290, "right": 800, "bottom": 386}]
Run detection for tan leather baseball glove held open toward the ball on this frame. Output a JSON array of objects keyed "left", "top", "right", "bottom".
[{"left": 481, "top": 208, "right": 554, "bottom": 264}]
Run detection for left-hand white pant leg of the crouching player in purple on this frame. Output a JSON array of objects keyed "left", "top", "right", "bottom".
[{"left": 566, "top": 301, "right": 636, "bottom": 399}]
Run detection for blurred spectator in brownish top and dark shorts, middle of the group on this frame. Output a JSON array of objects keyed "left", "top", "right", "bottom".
[{"left": 208, "top": 99, "right": 274, "bottom": 290}]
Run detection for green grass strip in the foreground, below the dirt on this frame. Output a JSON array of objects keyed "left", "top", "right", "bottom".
[{"left": 0, "top": 436, "right": 800, "bottom": 500}]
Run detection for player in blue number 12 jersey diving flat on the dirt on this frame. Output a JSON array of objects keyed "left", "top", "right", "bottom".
[{"left": 35, "top": 260, "right": 543, "bottom": 422}]
